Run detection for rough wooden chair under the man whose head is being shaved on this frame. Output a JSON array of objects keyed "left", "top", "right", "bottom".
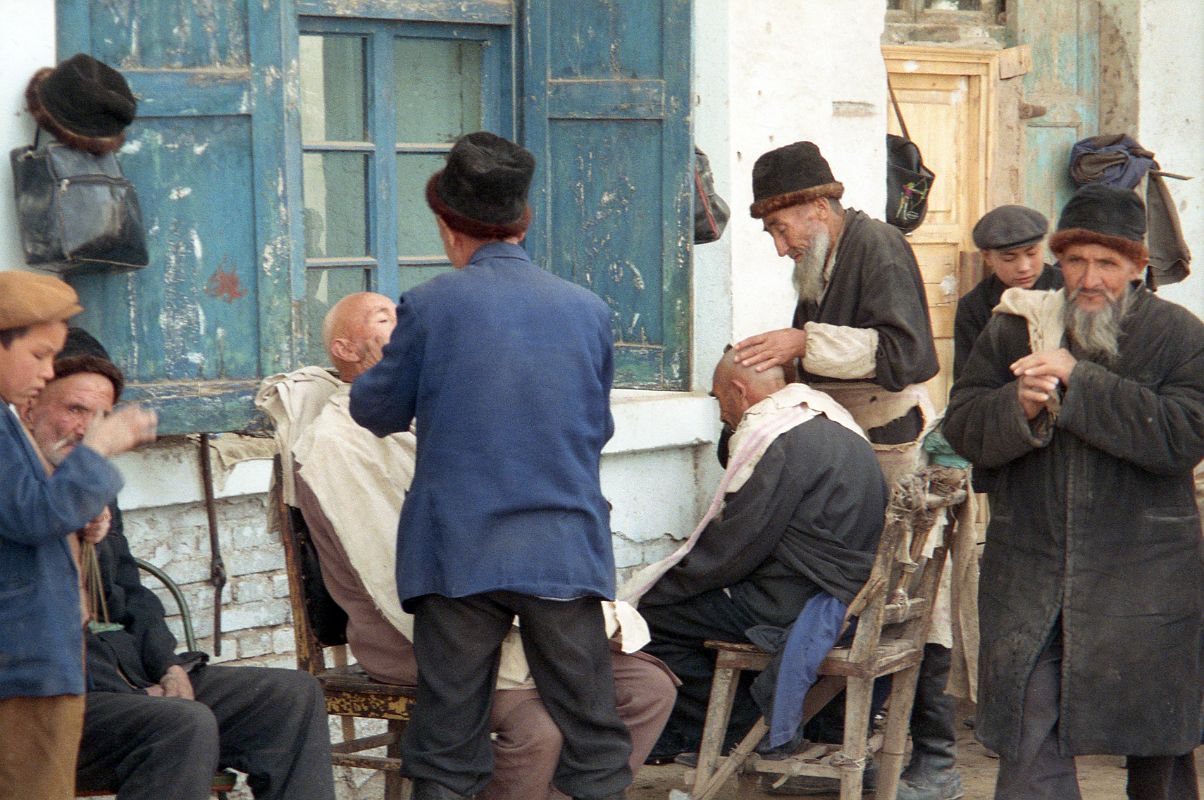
[{"left": 674, "top": 467, "right": 967, "bottom": 800}]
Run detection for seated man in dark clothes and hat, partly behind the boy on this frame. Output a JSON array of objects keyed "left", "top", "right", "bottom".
[{"left": 23, "top": 328, "right": 335, "bottom": 800}]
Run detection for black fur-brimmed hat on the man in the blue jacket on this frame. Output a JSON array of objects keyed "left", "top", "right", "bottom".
[{"left": 426, "top": 130, "right": 535, "bottom": 240}]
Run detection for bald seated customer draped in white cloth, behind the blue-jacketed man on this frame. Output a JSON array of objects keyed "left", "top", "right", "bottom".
[{"left": 293, "top": 292, "right": 675, "bottom": 800}]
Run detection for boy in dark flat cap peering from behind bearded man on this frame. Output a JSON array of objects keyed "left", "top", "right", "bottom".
[{"left": 954, "top": 206, "right": 1062, "bottom": 381}]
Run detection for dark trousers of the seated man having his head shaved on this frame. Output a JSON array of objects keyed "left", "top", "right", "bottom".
[{"left": 639, "top": 589, "right": 760, "bottom": 754}]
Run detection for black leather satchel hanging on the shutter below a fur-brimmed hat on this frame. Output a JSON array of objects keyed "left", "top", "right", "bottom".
[{"left": 10, "top": 139, "right": 149, "bottom": 275}]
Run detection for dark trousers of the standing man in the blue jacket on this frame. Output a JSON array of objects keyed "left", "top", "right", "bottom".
[{"left": 401, "top": 592, "right": 631, "bottom": 799}]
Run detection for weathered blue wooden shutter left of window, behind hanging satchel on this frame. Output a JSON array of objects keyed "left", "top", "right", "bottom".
[{"left": 58, "top": 0, "right": 294, "bottom": 434}]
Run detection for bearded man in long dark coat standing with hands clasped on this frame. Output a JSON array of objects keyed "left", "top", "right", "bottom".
[{"left": 944, "top": 183, "right": 1204, "bottom": 800}]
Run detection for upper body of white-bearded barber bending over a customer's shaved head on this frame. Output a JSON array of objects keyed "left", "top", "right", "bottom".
[{"left": 736, "top": 142, "right": 939, "bottom": 460}]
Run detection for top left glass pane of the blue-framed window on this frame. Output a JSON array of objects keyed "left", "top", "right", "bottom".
[{"left": 300, "top": 34, "right": 367, "bottom": 143}]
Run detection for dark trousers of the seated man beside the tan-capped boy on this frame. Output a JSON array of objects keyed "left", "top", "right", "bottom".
[{"left": 77, "top": 666, "right": 335, "bottom": 800}]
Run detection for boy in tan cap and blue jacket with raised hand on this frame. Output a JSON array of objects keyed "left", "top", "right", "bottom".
[{"left": 0, "top": 271, "right": 157, "bottom": 800}]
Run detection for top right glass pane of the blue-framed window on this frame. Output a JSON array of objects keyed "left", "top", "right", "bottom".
[{"left": 393, "top": 39, "right": 482, "bottom": 143}]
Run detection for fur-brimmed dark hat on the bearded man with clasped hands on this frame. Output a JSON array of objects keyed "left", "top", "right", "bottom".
[{"left": 1050, "top": 183, "right": 1150, "bottom": 264}]
